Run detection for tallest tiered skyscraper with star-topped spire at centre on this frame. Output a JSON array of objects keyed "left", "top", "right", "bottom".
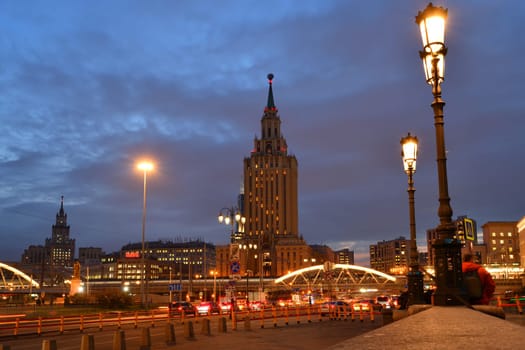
[{"left": 240, "top": 74, "right": 310, "bottom": 276}]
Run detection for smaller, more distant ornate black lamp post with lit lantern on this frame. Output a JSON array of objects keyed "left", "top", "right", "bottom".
[{"left": 401, "top": 133, "right": 424, "bottom": 305}]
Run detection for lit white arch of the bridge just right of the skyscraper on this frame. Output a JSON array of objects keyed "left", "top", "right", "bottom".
[{"left": 274, "top": 263, "right": 405, "bottom": 291}]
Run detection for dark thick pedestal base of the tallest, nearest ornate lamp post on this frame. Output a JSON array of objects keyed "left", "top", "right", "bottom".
[{"left": 432, "top": 238, "right": 468, "bottom": 306}]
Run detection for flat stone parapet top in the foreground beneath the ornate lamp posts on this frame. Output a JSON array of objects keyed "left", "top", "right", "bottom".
[{"left": 328, "top": 306, "right": 525, "bottom": 350}]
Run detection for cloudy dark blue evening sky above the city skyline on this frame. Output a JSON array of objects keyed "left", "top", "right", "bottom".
[{"left": 0, "top": 1, "right": 525, "bottom": 263}]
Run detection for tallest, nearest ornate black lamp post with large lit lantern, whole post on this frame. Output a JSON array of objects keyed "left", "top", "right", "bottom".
[{"left": 416, "top": 3, "right": 463, "bottom": 306}]
